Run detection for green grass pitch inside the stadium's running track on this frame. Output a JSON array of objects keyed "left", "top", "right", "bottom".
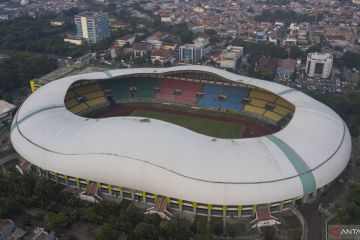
[{"left": 132, "top": 110, "right": 244, "bottom": 138}]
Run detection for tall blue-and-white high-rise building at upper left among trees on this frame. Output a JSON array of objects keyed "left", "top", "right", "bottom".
[{"left": 75, "top": 12, "right": 110, "bottom": 43}]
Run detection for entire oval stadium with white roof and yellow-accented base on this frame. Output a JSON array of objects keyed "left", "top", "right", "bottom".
[{"left": 11, "top": 65, "right": 351, "bottom": 217}]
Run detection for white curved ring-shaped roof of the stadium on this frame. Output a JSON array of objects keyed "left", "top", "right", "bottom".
[{"left": 11, "top": 65, "right": 351, "bottom": 205}]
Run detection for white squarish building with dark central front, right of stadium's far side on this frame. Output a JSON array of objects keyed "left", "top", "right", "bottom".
[{"left": 306, "top": 53, "right": 333, "bottom": 78}]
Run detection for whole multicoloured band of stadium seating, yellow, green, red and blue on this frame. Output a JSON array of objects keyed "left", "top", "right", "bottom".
[{"left": 65, "top": 77, "right": 294, "bottom": 122}]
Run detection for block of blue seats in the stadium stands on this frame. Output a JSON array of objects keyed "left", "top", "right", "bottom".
[{"left": 198, "top": 84, "right": 249, "bottom": 111}]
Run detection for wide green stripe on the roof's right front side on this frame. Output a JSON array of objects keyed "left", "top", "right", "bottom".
[{"left": 266, "top": 135, "right": 316, "bottom": 194}]
